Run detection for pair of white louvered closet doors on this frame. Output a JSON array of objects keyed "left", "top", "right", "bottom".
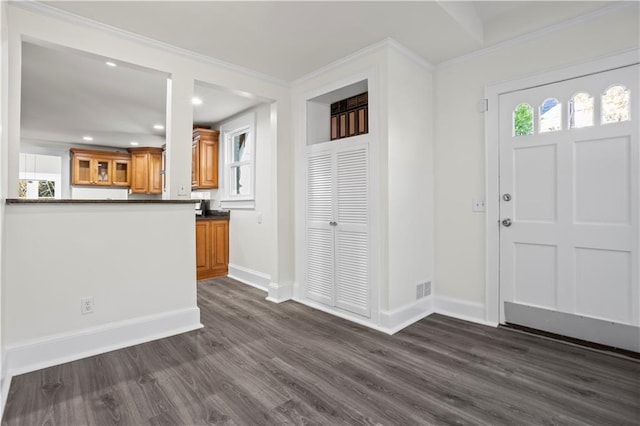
[{"left": 306, "top": 141, "right": 370, "bottom": 317}]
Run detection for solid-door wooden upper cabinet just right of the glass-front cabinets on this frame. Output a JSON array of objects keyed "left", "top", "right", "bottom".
[{"left": 129, "top": 147, "right": 162, "bottom": 194}]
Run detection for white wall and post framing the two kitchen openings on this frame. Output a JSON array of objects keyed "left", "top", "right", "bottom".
[{"left": 8, "top": 5, "right": 294, "bottom": 290}]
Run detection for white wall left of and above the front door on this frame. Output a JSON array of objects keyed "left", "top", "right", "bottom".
[{"left": 435, "top": 3, "right": 639, "bottom": 305}]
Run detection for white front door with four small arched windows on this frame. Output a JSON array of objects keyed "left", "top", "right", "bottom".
[{"left": 499, "top": 65, "right": 640, "bottom": 351}]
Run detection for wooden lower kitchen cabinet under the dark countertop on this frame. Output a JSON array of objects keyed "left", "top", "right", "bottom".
[{"left": 196, "top": 219, "right": 229, "bottom": 280}]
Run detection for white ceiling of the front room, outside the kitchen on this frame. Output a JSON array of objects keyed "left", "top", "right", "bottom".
[{"left": 38, "top": 1, "right": 611, "bottom": 82}]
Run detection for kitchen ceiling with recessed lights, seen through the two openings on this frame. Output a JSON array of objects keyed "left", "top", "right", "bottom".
[{"left": 21, "top": 42, "right": 262, "bottom": 148}]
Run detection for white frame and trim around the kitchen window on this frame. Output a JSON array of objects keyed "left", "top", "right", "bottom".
[{"left": 220, "top": 112, "right": 256, "bottom": 210}]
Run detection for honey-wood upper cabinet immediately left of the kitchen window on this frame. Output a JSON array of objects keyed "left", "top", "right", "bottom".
[{"left": 191, "top": 128, "right": 220, "bottom": 189}]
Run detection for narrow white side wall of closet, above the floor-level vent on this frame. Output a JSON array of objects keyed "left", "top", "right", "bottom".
[{"left": 387, "top": 49, "right": 434, "bottom": 310}]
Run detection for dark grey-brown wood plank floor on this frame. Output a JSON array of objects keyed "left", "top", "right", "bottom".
[{"left": 2, "top": 278, "right": 640, "bottom": 426}]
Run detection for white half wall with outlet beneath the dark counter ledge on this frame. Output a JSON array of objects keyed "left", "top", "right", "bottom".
[{"left": 2, "top": 204, "right": 196, "bottom": 347}]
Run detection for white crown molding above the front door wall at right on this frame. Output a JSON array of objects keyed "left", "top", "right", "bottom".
[{"left": 435, "top": 1, "right": 637, "bottom": 70}]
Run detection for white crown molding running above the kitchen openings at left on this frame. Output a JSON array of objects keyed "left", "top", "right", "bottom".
[{"left": 9, "top": 0, "right": 291, "bottom": 88}]
